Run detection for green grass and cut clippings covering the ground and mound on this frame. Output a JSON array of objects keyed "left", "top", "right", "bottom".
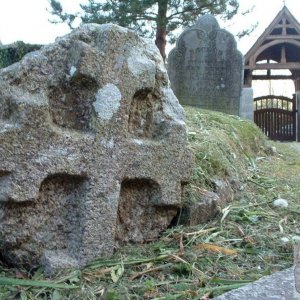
[{"left": 0, "top": 107, "right": 300, "bottom": 300}]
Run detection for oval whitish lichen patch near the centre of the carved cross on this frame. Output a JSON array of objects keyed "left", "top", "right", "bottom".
[{"left": 93, "top": 83, "right": 122, "bottom": 120}]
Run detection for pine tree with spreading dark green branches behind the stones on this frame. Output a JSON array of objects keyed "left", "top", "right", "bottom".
[{"left": 50, "top": 0, "right": 239, "bottom": 59}]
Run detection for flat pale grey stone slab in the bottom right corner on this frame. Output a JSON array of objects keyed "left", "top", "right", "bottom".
[{"left": 214, "top": 267, "right": 300, "bottom": 300}]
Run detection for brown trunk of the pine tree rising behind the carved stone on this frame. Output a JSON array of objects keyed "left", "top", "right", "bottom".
[{"left": 155, "top": 0, "right": 168, "bottom": 61}]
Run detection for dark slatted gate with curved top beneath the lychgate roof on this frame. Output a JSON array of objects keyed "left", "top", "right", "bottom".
[{"left": 254, "top": 95, "right": 296, "bottom": 141}]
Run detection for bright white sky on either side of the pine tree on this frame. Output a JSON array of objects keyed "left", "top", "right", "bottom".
[{"left": 0, "top": 0, "right": 300, "bottom": 54}]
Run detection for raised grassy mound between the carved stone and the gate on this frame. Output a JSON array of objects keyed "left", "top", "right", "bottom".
[{"left": 185, "top": 107, "right": 266, "bottom": 189}]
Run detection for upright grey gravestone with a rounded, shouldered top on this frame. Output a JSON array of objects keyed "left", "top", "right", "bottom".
[{"left": 168, "top": 15, "right": 243, "bottom": 115}]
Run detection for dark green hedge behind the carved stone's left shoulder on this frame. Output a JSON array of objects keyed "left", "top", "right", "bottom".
[{"left": 0, "top": 41, "right": 41, "bottom": 68}]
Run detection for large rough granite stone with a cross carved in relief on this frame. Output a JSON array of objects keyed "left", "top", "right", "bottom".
[{"left": 0, "top": 24, "right": 192, "bottom": 270}]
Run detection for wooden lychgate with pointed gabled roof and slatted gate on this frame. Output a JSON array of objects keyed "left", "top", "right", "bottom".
[{"left": 244, "top": 5, "right": 300, "bottom": 141}]
